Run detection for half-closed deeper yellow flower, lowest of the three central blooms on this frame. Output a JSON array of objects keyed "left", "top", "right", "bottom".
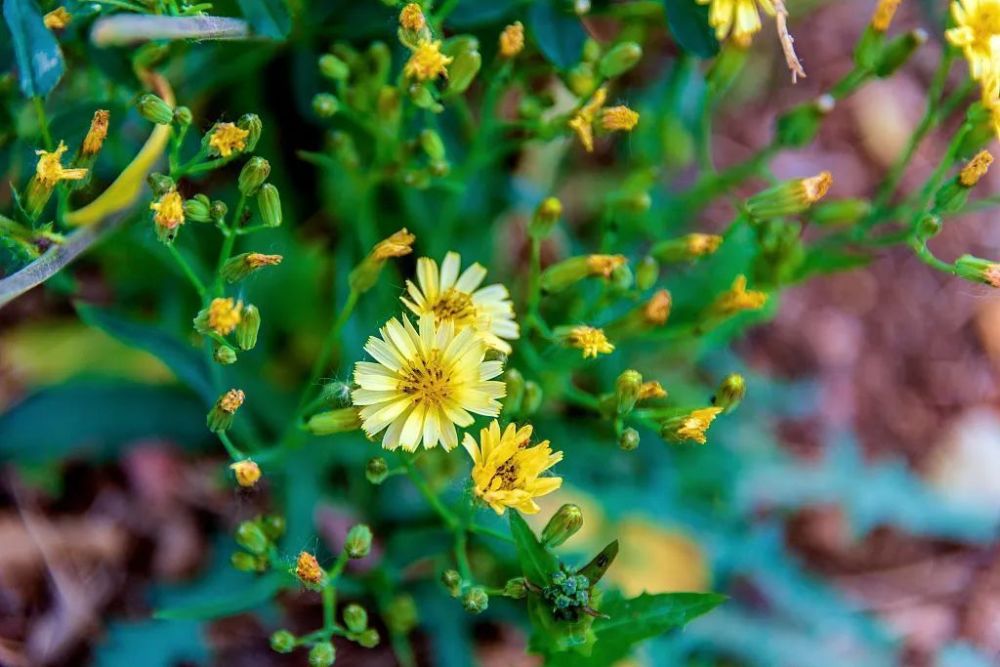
[{"left": 462, "top": 419, "right": 563, "bottom": 514}]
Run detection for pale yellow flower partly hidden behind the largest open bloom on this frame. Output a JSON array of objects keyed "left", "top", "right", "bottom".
[{"left": 402, "top": 252, "right": 520, "bottom": 354}]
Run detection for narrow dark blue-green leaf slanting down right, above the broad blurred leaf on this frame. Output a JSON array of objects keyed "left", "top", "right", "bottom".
[{"left": 76, "top": 303, "right": 215, "bottom": 404}]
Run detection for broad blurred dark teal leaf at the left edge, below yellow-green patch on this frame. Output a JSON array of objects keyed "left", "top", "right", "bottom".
[{"left": 0, "top": 380, "right": 209, "bottom": 463}]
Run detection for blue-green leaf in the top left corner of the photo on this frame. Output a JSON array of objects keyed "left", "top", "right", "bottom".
[{"left": 3, "top": 0, "right": 64, "bottom": 97}]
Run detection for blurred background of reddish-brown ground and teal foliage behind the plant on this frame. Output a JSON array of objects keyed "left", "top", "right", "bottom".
[{"left": 0, "top": 0, "right": 1000, "bottom": 667}]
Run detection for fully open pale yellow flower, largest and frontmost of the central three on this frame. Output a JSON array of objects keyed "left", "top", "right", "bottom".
[{"left": 351, "top": 314, "right": 506, "bottom": 452}]
